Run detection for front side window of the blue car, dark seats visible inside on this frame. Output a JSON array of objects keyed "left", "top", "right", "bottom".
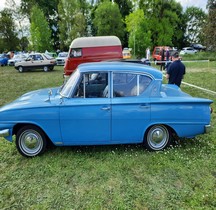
[{"left": 75, "top": 72, "right": 108, "bottom": 98}]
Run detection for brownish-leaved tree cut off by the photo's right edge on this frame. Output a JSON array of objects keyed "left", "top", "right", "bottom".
[{"left": 204, "top": 0, "right": 216, "bottom": 51}]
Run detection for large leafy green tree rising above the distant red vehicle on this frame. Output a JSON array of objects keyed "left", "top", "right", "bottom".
[{"left": 139, "top": 0, "right": 184, "bottom": 46}]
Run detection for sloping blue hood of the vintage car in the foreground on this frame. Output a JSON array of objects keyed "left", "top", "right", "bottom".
[{"left": 0, "top": 87, "right": 60, "bottom": 111}]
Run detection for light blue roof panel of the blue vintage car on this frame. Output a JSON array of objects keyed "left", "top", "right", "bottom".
[{"left": 78, "top": 61, "right": 163, "bottom": 80}]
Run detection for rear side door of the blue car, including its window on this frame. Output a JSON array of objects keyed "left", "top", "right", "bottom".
[{"left": 112, "top": 73, "right": 152, "bottom": 144}]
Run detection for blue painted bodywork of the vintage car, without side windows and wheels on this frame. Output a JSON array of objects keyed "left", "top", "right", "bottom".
[{"left": 0, "top": 62, "right": 212, "bottom": 145}]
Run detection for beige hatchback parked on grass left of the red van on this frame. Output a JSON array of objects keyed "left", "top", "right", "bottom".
[{"left": 15, "top": 53, "right": 56, "bottom": 73}]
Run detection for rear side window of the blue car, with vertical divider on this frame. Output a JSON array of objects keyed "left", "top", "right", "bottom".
[{"left": 113, "top": 73, "right": 152, "bottom": 97}]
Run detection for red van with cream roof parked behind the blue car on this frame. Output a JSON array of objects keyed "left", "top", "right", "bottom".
[{"left": 64, "top": 36, "right": 123, "bottom": 78}]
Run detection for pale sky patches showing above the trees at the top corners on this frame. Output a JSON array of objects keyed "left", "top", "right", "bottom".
[{"left": 0, "top": 0, "right": 208, "bottom": 12}]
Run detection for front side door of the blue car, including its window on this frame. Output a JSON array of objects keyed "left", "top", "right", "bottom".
[{"left": 60, "top": 72, "right": 111, "bottom": 145}]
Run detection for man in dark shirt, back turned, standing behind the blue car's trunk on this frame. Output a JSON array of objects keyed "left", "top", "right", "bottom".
[{"left": 166, "top": 52, "right": 186, "bottom": 87}]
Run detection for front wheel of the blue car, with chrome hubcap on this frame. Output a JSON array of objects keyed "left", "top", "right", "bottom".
[{"left": 16, "top": 125, "right": 47, "bottom": 157}]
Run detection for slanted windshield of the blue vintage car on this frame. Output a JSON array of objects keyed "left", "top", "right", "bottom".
[{"left": 60, "top": 70, "right": 80, "bottom": 97}]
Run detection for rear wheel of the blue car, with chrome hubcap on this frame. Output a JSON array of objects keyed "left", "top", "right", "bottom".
[{"left": 144, "top": 125, "right": 172, "bottom": 151}]
